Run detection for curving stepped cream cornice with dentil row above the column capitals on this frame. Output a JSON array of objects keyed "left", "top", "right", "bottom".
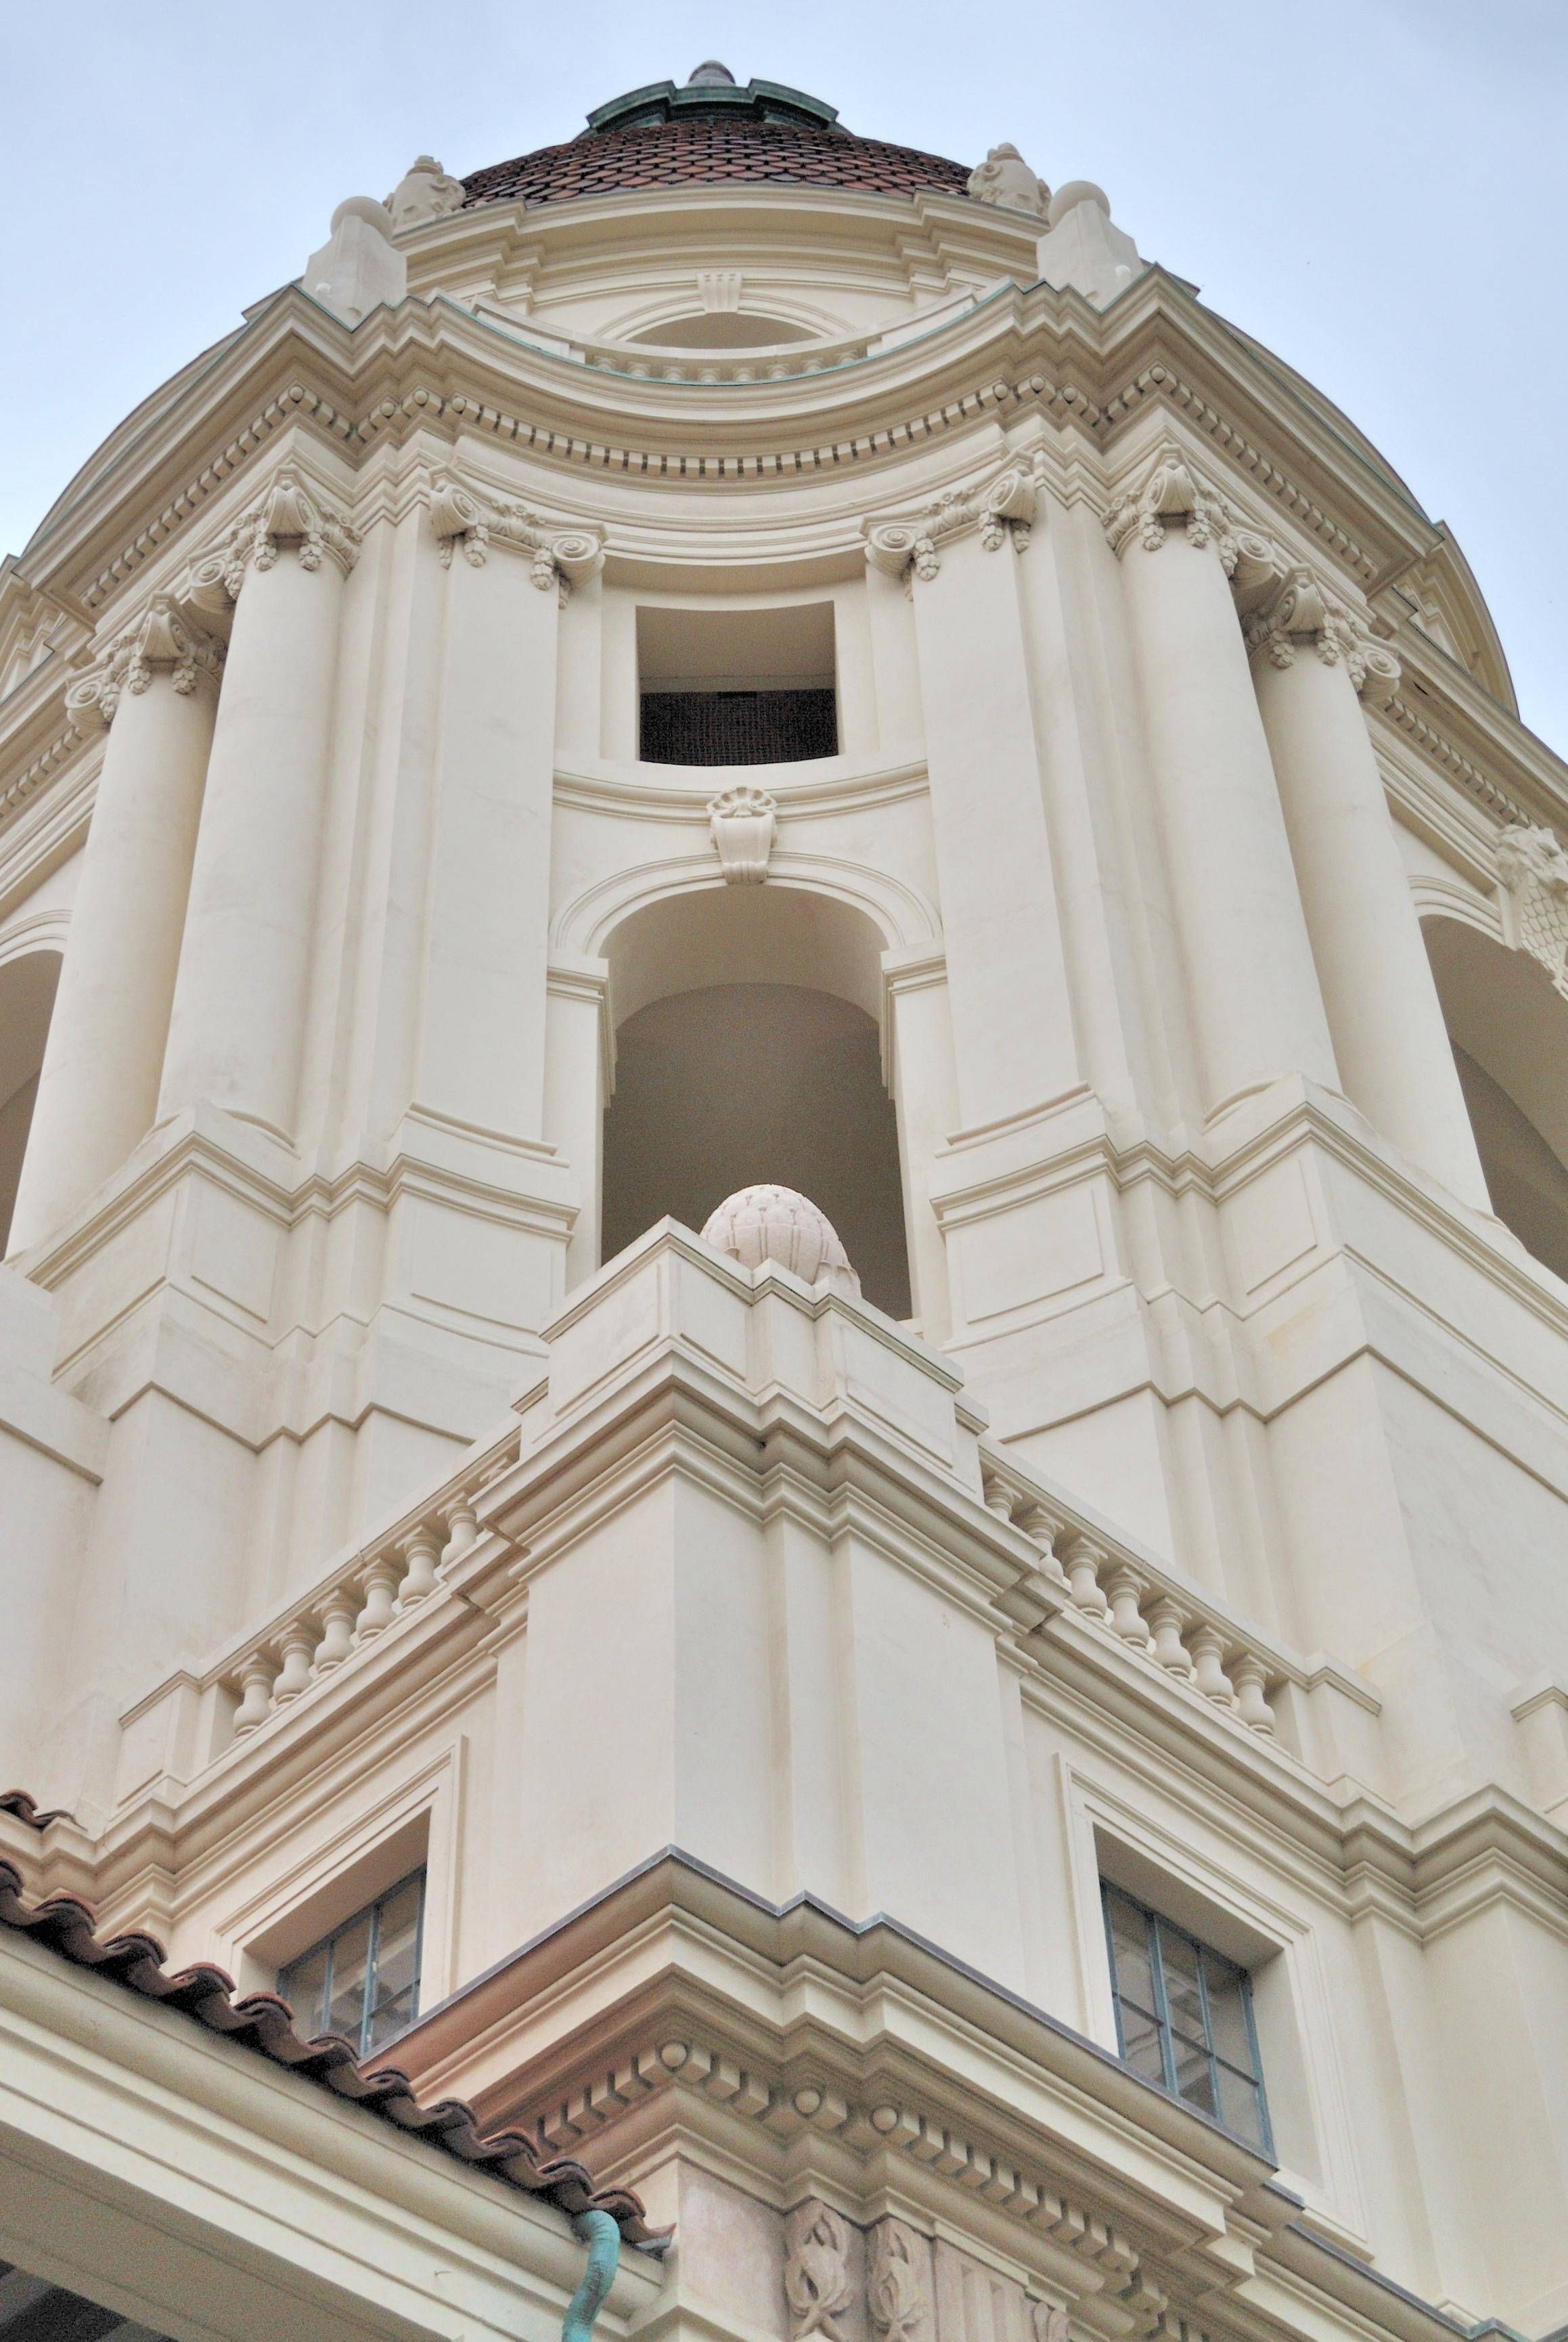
[{"left": 12, "top": 269, "right": 1441, "bottom": 627}]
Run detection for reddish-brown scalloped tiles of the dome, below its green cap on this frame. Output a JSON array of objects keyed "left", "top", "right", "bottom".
[{"left": 464, "top": 117, "right": 968, "bottom": 208}]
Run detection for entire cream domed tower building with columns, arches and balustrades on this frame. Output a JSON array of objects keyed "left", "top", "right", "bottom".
[{"left": 0, "top": 63, "right": 1568, "bottom": 2342}]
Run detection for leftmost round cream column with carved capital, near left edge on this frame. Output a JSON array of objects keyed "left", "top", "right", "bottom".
[{"left": 12, "top": 595, "right": 223, "bottom": 1251}]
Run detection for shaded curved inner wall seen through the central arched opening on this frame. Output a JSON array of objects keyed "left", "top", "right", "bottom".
[{"left": 602, "top": 984, "right": 910, "bottom": 1319}]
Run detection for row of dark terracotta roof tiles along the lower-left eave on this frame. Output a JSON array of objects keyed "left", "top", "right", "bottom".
[{"left": 0, "top": 1864, "right": 671, "bottom": 2251}]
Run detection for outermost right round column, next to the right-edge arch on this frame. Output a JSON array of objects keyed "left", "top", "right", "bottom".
[{"left": 1247, "top": 569, "right": 1491, "bottom": 1211}]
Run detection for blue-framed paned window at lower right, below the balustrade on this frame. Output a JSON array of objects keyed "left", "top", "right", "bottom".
[{"left": 1102, "top": 1881, "right": 1273, "bottom": 2157}]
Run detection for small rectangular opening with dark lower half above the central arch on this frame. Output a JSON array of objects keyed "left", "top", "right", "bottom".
[{"left": 637, "top": 602, "right": 839, "bottom": 766}]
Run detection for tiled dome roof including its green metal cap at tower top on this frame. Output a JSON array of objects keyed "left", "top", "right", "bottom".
[{"left": 462, "top": 68, "right": 968, "bottom": 208}]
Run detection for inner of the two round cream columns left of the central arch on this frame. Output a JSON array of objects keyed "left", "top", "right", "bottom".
[{"left": 157, "top": 471, "right": 359, "bottom": 1138}]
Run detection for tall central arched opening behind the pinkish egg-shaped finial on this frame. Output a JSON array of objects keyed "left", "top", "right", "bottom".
[{"left": 602, "top": 885, "right": 910, "bottom": 1319}]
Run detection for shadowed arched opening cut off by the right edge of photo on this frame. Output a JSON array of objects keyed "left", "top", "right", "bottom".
[{"left": 1423, "top": 918, "right": 1568, "bottom": 1279}]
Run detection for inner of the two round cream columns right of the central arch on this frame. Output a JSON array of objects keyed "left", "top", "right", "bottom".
[{"left": 1106, "top": 452, "right": 1339, "bottom": 1114}]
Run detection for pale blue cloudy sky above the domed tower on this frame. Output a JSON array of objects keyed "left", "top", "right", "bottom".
[{"left": 0, "top": 0, "right": 1568, "bottom": 754}]
